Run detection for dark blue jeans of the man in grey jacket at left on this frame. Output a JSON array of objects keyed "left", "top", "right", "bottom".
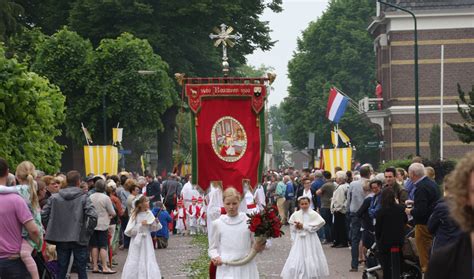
[{"left": 56, "top": 242, "right": 89, "bottom": 279}]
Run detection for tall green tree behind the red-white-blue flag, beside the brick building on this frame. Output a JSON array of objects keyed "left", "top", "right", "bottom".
[{"left": 282, "top": 0, "right": 379, "bottom": 166}]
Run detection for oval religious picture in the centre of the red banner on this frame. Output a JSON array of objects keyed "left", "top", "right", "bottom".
[{"left": 211, "top": 116, "right": 247, "bottom": 162}]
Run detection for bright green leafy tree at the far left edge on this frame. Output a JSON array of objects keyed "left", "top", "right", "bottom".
[{"left": 0, "top": 46, "right": 65, "bottom": 173}]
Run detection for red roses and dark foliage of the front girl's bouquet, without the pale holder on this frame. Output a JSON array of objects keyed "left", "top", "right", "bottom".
[{"left": 247, "top": 206, "right": 284, "bottom": 239}]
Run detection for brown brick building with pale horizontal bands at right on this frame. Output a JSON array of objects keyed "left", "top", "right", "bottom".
[{"left": 365, "top": 0, "right": 474, "bottom": 160}]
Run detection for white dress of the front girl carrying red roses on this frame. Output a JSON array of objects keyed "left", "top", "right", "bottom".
[{"left": 209, "top": 213, "right": 259, "bottom": 279}]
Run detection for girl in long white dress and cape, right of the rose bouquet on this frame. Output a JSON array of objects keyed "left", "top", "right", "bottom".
[{"left": 281, "top": 196, "right": 329, "bottom": 279}]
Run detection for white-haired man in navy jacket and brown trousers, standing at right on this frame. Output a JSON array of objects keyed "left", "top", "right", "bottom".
[{"left": 405, "top": 163, "right": 439, "bottom": 273}]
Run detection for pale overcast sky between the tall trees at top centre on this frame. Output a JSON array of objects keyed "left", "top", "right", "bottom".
[{"left": 246, "top": 0, "right": 328, "bottom": 106}]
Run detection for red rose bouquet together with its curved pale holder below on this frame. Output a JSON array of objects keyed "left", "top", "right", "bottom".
[{"left": 224, "top": 206, "right": 284, "bottom": 266}]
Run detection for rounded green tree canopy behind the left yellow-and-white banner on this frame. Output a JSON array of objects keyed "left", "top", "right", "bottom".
[{"left": 83, "top": 33, "right": 177, "bottom": 145}]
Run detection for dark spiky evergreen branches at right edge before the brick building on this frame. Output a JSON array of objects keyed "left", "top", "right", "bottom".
[{"left": 448, "top": 84, "right": 474, "bottom": 143}]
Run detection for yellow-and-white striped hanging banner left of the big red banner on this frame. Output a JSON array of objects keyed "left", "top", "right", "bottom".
[{"left": 84, "top": 145, "right": 118, "bottom": 174}]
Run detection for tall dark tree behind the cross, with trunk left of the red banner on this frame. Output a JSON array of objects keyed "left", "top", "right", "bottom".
[{"left": 70, "top": 0, "right": 281, "bottom": 173}]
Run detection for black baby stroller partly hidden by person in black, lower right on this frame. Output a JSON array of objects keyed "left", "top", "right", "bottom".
[{"left": 362, "top": 229, "right": 423, "bottom": 279}]
